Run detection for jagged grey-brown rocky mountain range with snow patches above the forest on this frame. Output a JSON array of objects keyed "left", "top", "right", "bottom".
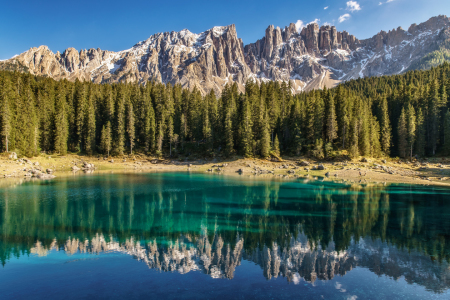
[{"left": 0, "top": 16, "right": 450, "bottom": 94}]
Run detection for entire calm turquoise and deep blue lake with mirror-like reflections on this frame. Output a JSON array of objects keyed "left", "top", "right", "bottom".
[{"left": 0, "top": 173, "right": 450, "bottom": 299}]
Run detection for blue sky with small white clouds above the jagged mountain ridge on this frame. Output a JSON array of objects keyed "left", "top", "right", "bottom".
[{"left": 0, "top": 0, "right": 450, "bottom": 59}]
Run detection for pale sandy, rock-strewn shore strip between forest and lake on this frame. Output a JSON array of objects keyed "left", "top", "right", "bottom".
[{"left": 0, "top": 154, "right": 450, "bottom": 187}]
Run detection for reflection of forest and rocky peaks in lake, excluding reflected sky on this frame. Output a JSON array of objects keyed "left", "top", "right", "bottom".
[{"left": 0, "top": 174, "right": 450, "bottom": 293}]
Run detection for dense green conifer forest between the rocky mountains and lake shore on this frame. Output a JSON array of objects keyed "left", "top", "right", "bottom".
[{"left": 0, "top": 63, "right": 450, "bottom": 159}]
